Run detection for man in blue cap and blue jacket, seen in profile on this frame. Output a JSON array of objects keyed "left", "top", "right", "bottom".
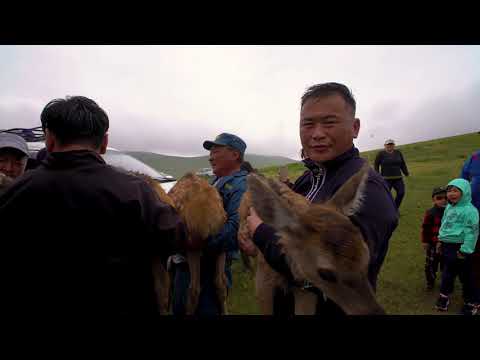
[{"left": 173, "top": 133, "right": 248, "bottom": 315}]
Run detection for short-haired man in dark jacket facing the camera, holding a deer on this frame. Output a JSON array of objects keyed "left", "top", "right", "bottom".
[{"left": 240, "top": 83, "right": 398, "bottom": 314}]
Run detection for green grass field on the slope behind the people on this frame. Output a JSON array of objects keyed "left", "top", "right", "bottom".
[{"left": 229, "top": 133, "right": 480, "bottom": 315}]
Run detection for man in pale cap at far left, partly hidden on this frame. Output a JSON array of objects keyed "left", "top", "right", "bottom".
[{"left": 0, "top": 132, "right": 29, "bottom": 190}]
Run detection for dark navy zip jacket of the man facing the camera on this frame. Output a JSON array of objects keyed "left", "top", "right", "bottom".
[{"left": 253, "top": 147, "right": 398, "bottom": 289}]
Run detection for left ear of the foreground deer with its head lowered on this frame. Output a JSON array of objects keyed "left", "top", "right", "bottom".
[{"left": 247, "top": 174, "right": 298, "bottom": 230}]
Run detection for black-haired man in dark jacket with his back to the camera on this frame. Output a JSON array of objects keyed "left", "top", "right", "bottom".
[{"left": 0, "top": 96, "right": 183, "bottom": 323}]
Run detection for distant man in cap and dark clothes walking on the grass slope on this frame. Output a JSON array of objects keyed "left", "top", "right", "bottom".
[{"left": 375, "top": 139, "right": 409, "bottom": 209}]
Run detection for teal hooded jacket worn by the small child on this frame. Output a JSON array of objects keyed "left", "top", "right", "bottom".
[{"left": 438, "top": 179, "right": 478, "bottom": 254}]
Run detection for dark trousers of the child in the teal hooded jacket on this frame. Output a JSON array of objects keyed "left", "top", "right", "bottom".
[{"left": 440, "top": 243, "right": 475, "bottom": 302}]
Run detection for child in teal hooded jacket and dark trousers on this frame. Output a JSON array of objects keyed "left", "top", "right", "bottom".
[{"left": 437, "top": 179, "right": 479, "bottom": 311}]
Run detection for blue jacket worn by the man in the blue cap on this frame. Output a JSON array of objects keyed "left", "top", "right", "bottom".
[{"left": 208, "top": 170, "right": 248, "bottom": 259}]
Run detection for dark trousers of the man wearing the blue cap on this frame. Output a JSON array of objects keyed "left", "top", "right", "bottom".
[{"left": 172, "top": 259, "right": 232, "bottom": 316}]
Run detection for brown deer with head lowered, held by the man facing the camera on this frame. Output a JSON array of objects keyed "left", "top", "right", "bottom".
[{"left": 239, "top": 164, "right": 384, "bottom": 314}]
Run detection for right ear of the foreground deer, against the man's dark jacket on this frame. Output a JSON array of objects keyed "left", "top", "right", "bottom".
[{"left": 325, "top": 163, "right": 370, "bottom": 216}]
